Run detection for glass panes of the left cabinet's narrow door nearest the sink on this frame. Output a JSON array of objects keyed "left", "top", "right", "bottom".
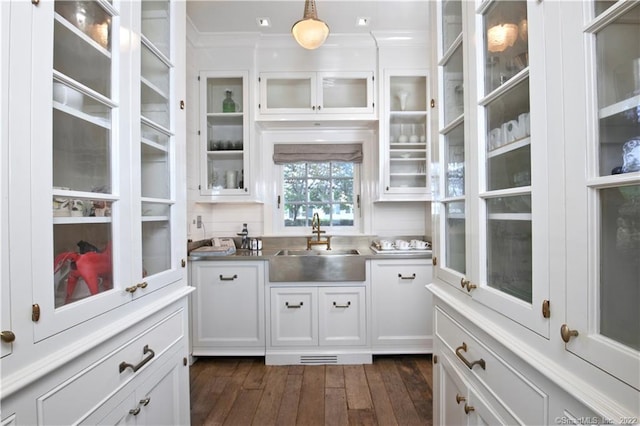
[{"left": 139, "top": 0, "right": 177, "bottom": 286}]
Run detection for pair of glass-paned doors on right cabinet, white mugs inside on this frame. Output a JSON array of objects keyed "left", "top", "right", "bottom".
[{"left": 436, "top": 1, "right": 548, "bottom": 335}]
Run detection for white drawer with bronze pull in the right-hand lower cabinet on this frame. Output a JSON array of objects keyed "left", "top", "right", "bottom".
[{"left": 435, "top": 307, "right": 549, "bottom": 425}]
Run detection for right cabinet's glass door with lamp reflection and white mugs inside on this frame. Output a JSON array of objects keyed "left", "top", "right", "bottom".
[{"left": 461, "top": 1, "right": 549, "bottom": 336}]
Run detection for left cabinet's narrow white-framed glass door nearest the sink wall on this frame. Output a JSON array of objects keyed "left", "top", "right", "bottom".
[{"left": 132, "top": 0, "right": 186, "bottom": 296}]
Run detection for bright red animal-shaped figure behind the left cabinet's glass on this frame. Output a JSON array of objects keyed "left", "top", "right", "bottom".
[{"left": 53, "top": 242, "right": 111, "bottom": 303}]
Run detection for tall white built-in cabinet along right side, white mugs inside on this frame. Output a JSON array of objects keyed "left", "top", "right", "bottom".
[{"left": 429, "top": 1, "right": 640, "bottom": 424}]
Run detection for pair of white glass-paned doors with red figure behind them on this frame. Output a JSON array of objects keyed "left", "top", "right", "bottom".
[{"left": 31, "top": 1, "right": 181, "bottom": 340}]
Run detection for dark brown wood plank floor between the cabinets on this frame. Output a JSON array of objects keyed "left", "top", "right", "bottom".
[{"left": 190, "top": 355, "right": 433, "bottom": 426}]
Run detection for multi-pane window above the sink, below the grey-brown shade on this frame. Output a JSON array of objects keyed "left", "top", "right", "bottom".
[{"left": 282, "top": 161, "right": 358, "bottom": 231}]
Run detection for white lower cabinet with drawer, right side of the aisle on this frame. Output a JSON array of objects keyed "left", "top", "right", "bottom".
[{"left": 433, "top": 306, "right": 606, "bottom": 425}]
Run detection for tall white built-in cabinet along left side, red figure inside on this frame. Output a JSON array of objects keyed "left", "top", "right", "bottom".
[{"left": 0, "top": 1, "right": 189, "bottom": 424}]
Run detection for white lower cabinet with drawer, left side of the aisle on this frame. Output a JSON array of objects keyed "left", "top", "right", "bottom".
[{"left": 2, "top": 293, "right": 190, "bottom": 425}]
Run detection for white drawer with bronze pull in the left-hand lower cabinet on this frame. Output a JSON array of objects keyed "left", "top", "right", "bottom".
[{"left": 37, "top": 310, "right": 186, "bottom": 425}]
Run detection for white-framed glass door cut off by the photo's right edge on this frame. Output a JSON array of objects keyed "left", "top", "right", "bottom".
[{"left": 554, "top": 2, "right": 640, "bottom": 389}]
